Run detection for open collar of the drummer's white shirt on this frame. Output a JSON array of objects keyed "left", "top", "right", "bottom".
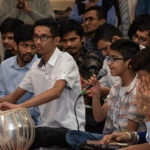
[{"left": 38, "top": 47, "right": 62, "bottom": 68}]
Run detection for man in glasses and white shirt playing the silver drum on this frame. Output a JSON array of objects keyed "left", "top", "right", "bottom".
[{"left": 0, "top": 18, "right": 85, "bottom": 148}]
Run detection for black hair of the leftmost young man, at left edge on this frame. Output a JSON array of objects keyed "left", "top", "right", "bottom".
[{"left": 0, "top": 18, "right": 24, "bottom": 34}]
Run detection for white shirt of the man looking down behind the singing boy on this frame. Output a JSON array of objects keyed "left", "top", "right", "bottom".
[{"left": 100, "top": 57, "right": 121, "bottom": 88}]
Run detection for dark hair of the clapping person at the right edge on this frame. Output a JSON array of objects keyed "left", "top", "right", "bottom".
[{"left": 130, "top": 46, "right": 150, "bottom": 73}]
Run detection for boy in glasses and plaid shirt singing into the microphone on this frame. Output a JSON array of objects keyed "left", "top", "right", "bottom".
[{"left": 66, "top": 40, "right": 145, "bottom": 149}]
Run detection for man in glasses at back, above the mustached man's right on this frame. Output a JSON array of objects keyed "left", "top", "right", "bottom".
[{"left": 82, "top": 6, "right": 106, "bottom": 63}]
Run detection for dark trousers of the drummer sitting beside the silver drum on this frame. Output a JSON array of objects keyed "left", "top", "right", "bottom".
[{"left": 30, "top": 127, "right": 68, "bottom": 150}]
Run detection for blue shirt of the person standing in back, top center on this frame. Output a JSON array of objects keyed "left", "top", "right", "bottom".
[{"left": 69, "top": 0, "right": 116, "bottom": 25}]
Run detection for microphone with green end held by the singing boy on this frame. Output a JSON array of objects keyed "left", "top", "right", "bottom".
[{"left": 80, "top": 69, "right": 107, "bottom": 96}]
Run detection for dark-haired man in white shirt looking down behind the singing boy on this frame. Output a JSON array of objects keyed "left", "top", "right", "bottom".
[{"left": 94, "top": 24, "right": 122, "bottom": 95}]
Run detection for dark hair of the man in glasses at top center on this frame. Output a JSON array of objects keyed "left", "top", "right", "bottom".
[{"left": 84, "top": 6, "right": 107, "bottom": 20}]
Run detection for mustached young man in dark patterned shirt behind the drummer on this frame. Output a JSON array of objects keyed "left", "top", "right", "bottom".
[{"left": 60, "top": 19, "right": 102, "bottom": 84}]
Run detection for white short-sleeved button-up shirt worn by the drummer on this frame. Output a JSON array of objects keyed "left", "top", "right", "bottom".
[{"left": 20, "top": 48, "right": 85, "bottom": 130}]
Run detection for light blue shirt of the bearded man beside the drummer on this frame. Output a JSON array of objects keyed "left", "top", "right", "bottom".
[{"left": 0, "top": 56, "right": 40, "bottom": 125}]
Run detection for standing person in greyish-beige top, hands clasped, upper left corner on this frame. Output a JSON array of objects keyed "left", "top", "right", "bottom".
[{"left": 0, "top": 0, "right": 55, "bottom": 24}]
